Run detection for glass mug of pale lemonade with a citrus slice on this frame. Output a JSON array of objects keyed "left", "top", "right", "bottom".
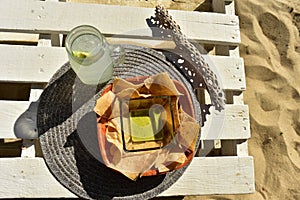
[{"left": 66, "top": 25, "right": 124, "bottom": 85}]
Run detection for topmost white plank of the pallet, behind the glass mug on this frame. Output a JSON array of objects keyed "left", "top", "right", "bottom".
[{"left": 0, "top": 0, "right": 240, "bottom": 44}]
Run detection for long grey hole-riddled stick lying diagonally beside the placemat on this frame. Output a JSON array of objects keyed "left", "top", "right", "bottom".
[{"left": 147, "top": 6, "right": 226, "bottom": 111}]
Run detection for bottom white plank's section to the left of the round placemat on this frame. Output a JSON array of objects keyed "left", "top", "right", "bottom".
[{"left": 0, "top": 158, "right": 76, "bottom": 198}]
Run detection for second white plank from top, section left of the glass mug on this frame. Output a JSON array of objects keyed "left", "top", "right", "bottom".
[{"left": 0, "top": 45, "right": 68, "bottom": 83}]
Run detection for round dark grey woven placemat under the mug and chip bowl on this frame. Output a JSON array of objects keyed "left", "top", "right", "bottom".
[{"left": 37, "top": 46, "right": 201, "bottom": 199}]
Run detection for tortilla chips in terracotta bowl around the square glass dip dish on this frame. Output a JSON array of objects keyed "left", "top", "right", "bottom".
[{"left": 94, "top": 73, "right": 200, "bottom": 180}]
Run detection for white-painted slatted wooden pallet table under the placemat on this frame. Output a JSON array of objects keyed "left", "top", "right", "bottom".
[{"left": 0, "top": 0, "right": 255, "bottom": 198}]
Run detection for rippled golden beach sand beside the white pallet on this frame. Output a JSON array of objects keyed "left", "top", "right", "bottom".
[{"left": 68, "top": 0, "right": 300, "bottom": 200}]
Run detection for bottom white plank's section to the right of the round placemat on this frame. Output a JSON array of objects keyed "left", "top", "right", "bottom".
[{"left": 160, "top": 156, "right": 255, "bottom": 196}]
